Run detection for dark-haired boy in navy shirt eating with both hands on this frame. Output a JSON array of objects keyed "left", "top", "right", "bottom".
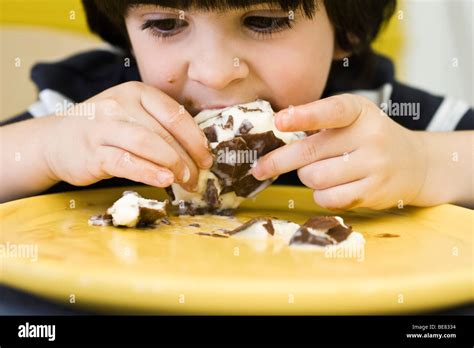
[{"left": 0, "top": 0, "right": 474, "bottom": 209}]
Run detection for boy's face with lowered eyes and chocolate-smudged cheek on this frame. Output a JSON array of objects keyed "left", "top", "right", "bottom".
[{"left": 125, "top": 2, "right": 337, "bottom": 115}]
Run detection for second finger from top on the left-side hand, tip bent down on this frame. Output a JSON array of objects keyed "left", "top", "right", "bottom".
[{"left": 100, "top": 121, "right": 190, "bottom": 183}]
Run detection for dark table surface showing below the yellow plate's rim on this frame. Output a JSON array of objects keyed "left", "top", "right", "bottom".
[{"left": 0, "top": 286, "right": 474, "bottom": 315}]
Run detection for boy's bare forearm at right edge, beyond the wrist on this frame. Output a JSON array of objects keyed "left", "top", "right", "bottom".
[{"left": 411, "top": 131, "right": 474, "bottom": 208}]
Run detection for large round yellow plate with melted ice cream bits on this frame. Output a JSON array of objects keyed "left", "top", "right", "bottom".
[{"left": 0, "top": 186, "right": 474, "bottom": 314}]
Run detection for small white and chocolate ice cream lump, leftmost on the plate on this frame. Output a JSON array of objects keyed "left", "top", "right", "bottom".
[{"left": 89, "top": 191, "right": 168, "bottom": 227}]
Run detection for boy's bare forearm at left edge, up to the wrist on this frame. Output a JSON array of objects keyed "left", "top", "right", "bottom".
[{"left": 0, "top": 117, "right": 58, "bottom": 202}]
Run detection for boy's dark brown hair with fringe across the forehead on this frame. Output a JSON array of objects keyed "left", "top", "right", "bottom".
[{"left": 82, "top": 0, "right": 396, "bottom": 55}]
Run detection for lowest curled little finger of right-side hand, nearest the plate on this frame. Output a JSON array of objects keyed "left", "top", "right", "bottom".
[{"left": 313, "top": 178, "right": 372, "bottom": 210}]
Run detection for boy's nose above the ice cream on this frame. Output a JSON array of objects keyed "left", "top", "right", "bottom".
[{"left": 188, "top": 44, "right": 249, "bottom": 90}]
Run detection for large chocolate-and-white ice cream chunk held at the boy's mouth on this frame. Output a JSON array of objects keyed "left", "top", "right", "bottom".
[{"left": 167, "top": 100, "right": 306, "bottom": 214}]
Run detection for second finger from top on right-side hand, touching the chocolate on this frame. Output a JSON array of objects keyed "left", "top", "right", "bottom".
[{"left": 252, "top": 129, "right": 357, "bottom": 180}]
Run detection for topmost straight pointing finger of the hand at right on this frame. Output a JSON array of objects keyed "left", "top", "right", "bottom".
[{"left": 275, "top": 94, "right": 363, "bottom": 132}]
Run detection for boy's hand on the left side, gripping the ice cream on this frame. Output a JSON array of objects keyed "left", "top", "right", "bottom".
[{"left": 46, "top": 82, "right": 212, "bottom": 190}]
